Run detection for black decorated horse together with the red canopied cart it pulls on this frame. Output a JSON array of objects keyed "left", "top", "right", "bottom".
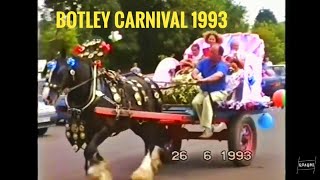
[{"left": 42, "top": 33, "right": 282, "bottom": 180}]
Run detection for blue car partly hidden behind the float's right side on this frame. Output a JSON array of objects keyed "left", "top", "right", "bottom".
[{"left": 262, "top": 64, "right": 286, "bottom": 97}]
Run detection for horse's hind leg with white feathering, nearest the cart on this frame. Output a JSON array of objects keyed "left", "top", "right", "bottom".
[{"left": 131, "top": 123, "right": 162, "bottom": 180}]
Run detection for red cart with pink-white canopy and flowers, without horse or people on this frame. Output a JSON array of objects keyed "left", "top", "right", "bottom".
[{"left": 95, "top": 33, "right": 278, "bottom": 166}]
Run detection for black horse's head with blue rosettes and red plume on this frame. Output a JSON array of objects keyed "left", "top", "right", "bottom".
[{"left": 43, "top": 39, "right": 111, "bottom": 107}]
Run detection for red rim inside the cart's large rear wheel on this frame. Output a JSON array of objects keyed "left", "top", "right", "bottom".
[{"left": 240, "top": 124, "right": 254, "bottom": 152}]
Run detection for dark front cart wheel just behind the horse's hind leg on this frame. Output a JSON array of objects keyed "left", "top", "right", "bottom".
[{"left": 160, "top": 139, "right": 182, "bottom": 164}]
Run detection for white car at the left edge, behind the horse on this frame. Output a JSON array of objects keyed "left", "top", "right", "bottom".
[{"left": 38, "top": 96, "right": 56, "bottom": 136}]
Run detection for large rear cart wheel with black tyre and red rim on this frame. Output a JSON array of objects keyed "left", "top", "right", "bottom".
[{"left": 227, "top": 115, "right": 257, "bottom": 166}]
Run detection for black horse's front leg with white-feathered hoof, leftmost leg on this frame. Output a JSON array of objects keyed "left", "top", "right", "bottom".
[{"left": 84, "top": 126, "right": 112, "bottom": 180}]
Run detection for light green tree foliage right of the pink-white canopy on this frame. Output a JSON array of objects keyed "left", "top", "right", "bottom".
[{"left": 252, "top": 23, "right": 285, "bottom": 64}]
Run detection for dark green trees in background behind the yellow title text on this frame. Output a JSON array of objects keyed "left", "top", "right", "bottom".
[{"left": 40, "top": 0, "right": 255, "bottom": 73}]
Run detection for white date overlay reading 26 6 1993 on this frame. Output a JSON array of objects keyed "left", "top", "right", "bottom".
[{"left": 171, "top": 150, "right": 253, "bottom": 161}]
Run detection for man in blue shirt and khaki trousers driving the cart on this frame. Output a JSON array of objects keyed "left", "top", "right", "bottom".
[{"left": 192, "top": 44, "right": 228, "bottom": 138}]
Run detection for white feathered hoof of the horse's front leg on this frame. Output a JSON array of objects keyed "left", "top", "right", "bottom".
[{"left": 88, "top": 161, "right": 112, "bottom": 180}]
